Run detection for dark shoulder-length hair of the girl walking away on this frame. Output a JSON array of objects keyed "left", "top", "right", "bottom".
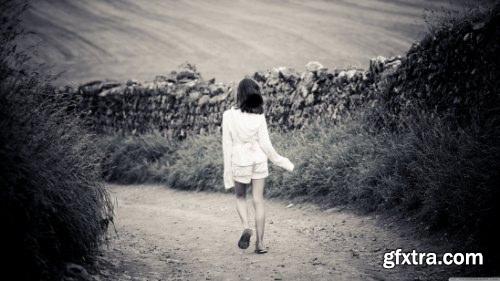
[{"left": 236, "top": 78, "right": 264, "bottom": 114}]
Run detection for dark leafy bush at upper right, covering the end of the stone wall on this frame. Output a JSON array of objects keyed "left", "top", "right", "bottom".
[{"left": 369, "top": 3, "right": 500, "bottom": 130}]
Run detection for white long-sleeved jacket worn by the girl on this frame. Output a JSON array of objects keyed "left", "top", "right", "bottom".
[{"left": 222, "top": 107, "right": 294, "bottom": 189}]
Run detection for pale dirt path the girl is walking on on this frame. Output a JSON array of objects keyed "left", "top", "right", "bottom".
[{"left": 94, "top": 185, "right": 458, "bottom": 281}]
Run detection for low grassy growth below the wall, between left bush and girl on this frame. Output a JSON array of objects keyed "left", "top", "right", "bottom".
[{"left": 101, "top": 134, "right": 224, "bottom": 190}]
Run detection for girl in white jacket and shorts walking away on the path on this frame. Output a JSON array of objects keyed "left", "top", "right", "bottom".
[{"left": 222, "top": 78, "right": 294, "bottom": 254}]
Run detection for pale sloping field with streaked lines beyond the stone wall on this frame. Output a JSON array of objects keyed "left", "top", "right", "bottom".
[{"left": 24, "top": 0, "right": 468, "bottom": 83}]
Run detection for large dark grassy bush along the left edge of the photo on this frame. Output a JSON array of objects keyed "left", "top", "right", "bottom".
[{"left": 0, "top": 1, "right": 112, "bottom": 280}]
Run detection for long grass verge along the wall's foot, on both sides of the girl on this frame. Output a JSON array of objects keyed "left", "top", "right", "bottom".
[{"left": 101, "top": 111, "right": 500, "bottom": 230}]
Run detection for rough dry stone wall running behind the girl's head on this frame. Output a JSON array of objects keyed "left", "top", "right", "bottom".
[{"left": 58, "top": 57, "right": 401, "bottom": 139}]
